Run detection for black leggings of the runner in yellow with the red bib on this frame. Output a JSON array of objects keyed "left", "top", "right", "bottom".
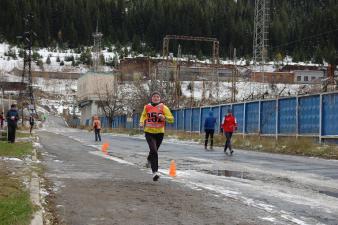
[{"left": 145, "top": 132, "right": 164, "bottom": 173}]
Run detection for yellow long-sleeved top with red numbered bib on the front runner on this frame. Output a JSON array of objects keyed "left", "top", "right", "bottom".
[{"left": 140, "top": 103, "right": 174, "bottom": 134}]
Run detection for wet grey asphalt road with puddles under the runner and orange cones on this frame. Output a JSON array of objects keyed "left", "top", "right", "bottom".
[{"left": 39, "top": 117, "right": 338, "bottom": 224}]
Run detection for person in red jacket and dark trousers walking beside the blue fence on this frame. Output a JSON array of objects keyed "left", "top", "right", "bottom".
[{"left": 221, "top": 109, "right": 237, "bottom": 155}]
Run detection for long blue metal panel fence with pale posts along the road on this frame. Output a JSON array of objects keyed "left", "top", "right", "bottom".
[{"left": 94, "top": 92, "right": 338, "bottom": 140}]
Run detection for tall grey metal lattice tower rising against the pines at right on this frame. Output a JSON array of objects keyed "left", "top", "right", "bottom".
[{"left": 253, "top": 0, "right": 270, "bottom": 65}]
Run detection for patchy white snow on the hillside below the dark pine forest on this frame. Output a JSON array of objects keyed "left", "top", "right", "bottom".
[{"left": 0, "top": 43, "right": 313, "bottom": 113}]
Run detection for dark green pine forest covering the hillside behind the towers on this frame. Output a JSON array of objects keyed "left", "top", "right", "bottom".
[{"left": 0, "top": 0, "right": 338, "bottom": 59}]
